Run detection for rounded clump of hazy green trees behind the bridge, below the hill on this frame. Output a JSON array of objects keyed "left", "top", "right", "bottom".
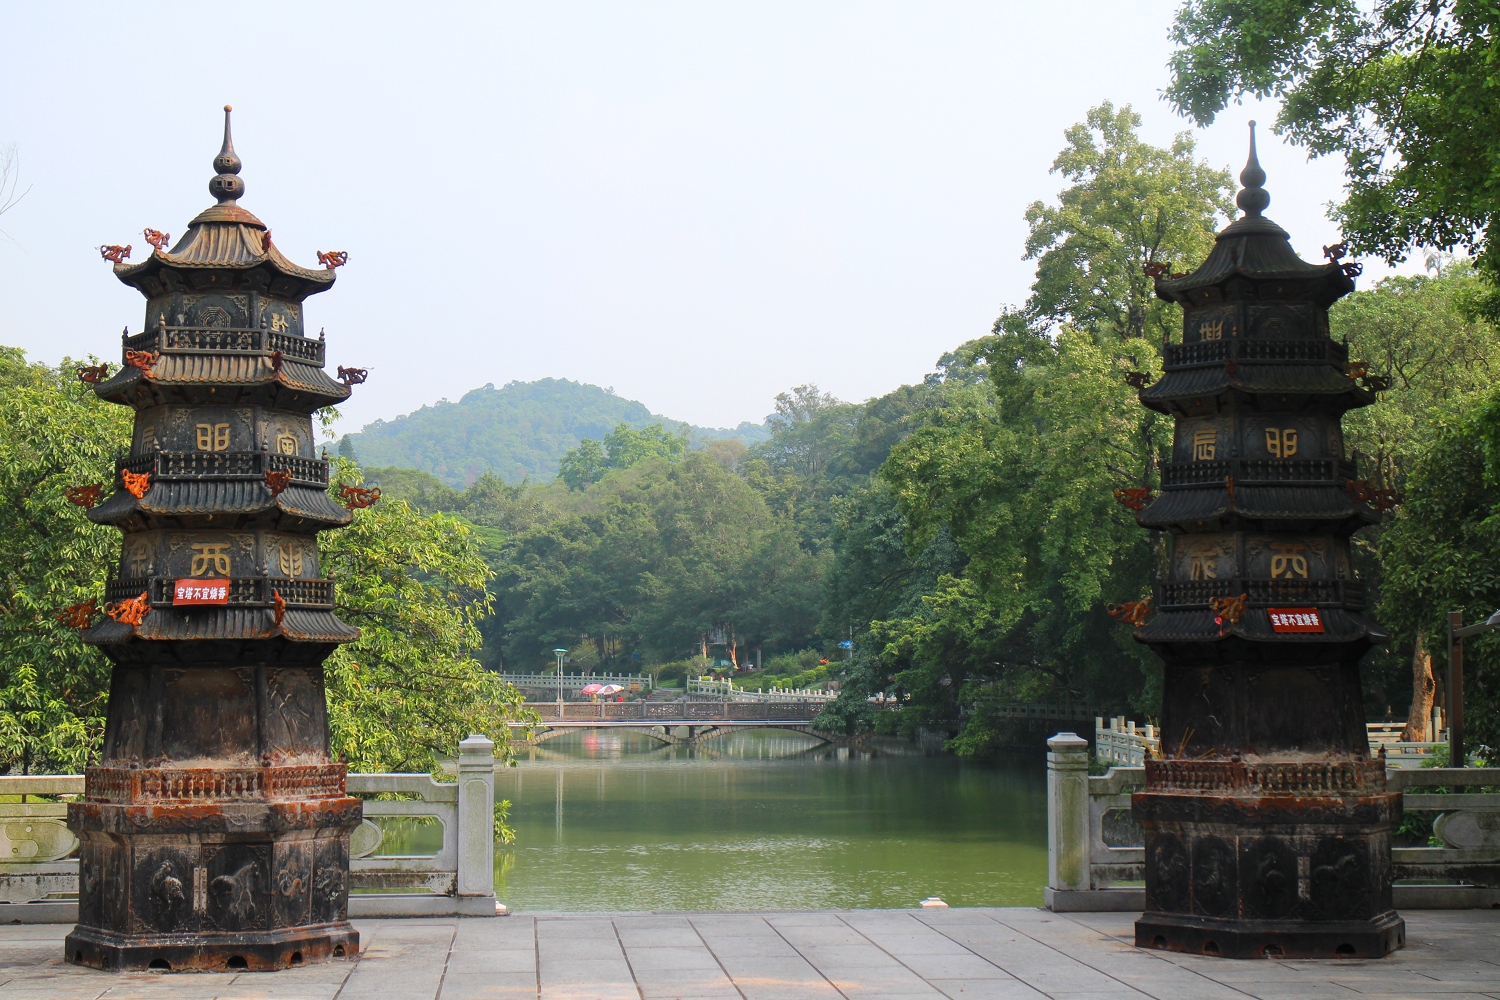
[{"left": 500, "top": 451, "right": 822, "bottom": 663}]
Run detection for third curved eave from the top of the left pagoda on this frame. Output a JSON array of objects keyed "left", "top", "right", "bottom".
[{"left": 89, "top": 480, "right": 354, "bottom": 529}]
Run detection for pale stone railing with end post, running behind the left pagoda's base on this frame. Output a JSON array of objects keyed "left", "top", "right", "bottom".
[{"left": 0, "top": 736, "right": 497, "bottom": 924}]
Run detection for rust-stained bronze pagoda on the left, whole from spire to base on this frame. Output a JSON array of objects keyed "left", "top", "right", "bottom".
[{"left": 66, "top": 108, "right": 362, "bottom": 970}]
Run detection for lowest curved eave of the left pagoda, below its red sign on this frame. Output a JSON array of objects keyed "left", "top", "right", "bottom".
[{"left": 81, "top": 607, "right": 360, "bottom": 646}]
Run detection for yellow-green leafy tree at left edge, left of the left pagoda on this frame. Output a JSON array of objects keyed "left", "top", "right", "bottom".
[{"left": 0, "top": 348, "right": 132, "bottom": 772}]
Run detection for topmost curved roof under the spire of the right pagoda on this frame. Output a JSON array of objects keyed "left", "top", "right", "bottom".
[{"left": 1155, "top": 216, "right": 1355, "bottom": 307}]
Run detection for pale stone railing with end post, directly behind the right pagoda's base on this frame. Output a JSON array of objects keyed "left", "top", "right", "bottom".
[{"left": 1046, "top": 733, "right": 1500, "bottom": 912}]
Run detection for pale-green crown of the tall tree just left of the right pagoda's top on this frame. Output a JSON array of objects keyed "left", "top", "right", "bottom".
[{"left": 1026, "top": 100, "right": 1235, "bottom": 339}]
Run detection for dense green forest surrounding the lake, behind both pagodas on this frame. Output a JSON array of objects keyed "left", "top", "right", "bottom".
[{"left": 0, "top": 91, "right": 1500, "bottom": 771}]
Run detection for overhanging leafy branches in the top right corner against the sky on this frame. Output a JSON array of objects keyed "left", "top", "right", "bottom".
[{"left": 1167, "top": 0, "right": 1500, "bottom": 316}]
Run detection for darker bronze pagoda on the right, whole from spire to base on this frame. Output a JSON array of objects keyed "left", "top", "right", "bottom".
[{"left": 1134, "top": 123, "right": 1406, "bottom": 958}]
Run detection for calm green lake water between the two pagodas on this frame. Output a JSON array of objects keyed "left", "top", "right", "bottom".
[{"left": 495, "top": 730, "right": 1047, "bottom": 912}]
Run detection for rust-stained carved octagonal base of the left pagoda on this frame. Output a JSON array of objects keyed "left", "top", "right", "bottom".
[{"left": 66, "top": 765, "right": 362, "bottom": 970}]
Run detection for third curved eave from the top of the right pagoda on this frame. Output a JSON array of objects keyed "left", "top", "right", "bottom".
[{"left": 1136, "top": 486, "right": 1380, "bottom": 531}]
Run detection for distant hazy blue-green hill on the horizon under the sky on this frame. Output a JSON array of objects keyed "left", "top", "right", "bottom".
[{"left": 339, "top": 378, "right": 771, "bottom": 489}]
